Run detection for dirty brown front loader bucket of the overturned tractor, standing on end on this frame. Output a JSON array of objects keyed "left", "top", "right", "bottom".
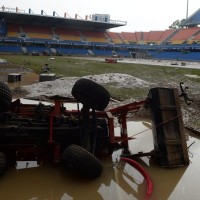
[{"left": 148, "top": 88, "right": 189, "bottom": 167}]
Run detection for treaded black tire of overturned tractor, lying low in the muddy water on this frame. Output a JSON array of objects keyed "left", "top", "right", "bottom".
[{"left": 62, "top": 144, "right": 103, "bottom": 178}]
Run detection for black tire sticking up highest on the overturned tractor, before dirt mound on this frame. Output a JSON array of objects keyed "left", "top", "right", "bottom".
[{"left": 71, "top": 78, "right": 110, "bottom": 111}]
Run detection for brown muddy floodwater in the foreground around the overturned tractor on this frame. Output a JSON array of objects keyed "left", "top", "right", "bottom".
[{"left": 0, "top": 117, "right": 200, "bottom": 200}]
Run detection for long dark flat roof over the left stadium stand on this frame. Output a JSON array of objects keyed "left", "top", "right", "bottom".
[{"left": 0, "top": 11, "right": 126, "bottom": 30}]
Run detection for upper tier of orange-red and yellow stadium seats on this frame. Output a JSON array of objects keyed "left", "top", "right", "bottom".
[{"left": 4, "top": 24, "right": 200, "bottom": 44}]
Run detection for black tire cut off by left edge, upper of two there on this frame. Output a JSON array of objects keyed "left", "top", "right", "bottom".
[{"left": 0, "top": 82, "right": 12, "bottom": 112}]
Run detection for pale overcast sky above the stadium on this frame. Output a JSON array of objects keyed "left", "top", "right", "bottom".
[{"left": 0, "top": 0, "right": 200, "bottom": 32}]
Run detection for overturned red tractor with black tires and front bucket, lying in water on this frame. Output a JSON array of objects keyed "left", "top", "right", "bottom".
[{"left": 0, "top": 78, "right": 189, "bottom": 178}]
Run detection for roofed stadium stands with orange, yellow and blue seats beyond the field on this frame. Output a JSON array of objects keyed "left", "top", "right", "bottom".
[{"left": 0, "top": 9, "right": 200, "bottom": 61}]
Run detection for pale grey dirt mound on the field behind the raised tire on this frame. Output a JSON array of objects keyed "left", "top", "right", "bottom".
[{"left": 21, "top": 73, "right": 153, "bottom": 98}]
